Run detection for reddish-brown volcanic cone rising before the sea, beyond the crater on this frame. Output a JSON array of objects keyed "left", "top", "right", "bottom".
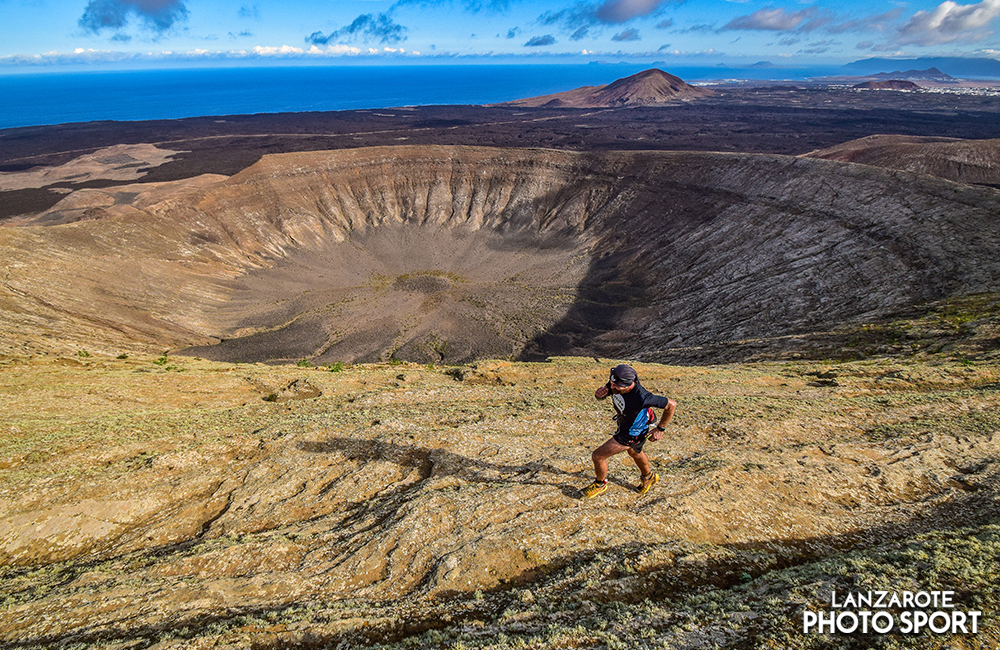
[{"left": 506, "top": 68, "right": 713, "bottom": 108}]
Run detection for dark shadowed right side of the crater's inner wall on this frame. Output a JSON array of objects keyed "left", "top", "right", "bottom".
[{"left": 520, "top": 149, "right": 1000, "bottom": 363}]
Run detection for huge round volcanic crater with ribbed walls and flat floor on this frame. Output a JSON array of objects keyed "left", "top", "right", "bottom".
[{"left": 0, "top": 147, "right": 1000, "bottom": 365}]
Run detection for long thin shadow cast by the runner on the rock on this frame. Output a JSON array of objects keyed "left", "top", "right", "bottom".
[{"left": 298, "top": 438, "right": 589, "bottom": 498}]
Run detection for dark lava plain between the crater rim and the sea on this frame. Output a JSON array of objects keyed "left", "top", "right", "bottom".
[{"left": 0, "top": 86, "right": 1000, "bottom": 218}]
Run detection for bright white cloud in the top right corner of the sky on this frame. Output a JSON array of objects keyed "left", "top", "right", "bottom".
[{"left": 896, "top": 0, "right": 1000, "bottom": 46}]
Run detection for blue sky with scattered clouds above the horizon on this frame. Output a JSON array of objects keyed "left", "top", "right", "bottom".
[{"left": 0, "top": 0, "right": 1000, "bottom": 69}]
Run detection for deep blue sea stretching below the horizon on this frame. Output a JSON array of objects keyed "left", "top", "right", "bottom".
[{"left": 0, "top": 64, "right": 840, "bottom": 129}]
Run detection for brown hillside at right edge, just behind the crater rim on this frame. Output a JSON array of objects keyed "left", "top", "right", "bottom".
[{"left": 805, "top": 135, "right": 1000, "bottom": 185}]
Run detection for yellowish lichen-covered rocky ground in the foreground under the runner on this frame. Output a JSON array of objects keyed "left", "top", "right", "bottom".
[{"left": 0, "top": 336, "right": 1000, "bottom": 648}]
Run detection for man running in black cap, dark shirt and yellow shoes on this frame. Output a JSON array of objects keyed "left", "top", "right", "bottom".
[{"left": 583, "top": 364, "right": 677, "bottom": 499}]
